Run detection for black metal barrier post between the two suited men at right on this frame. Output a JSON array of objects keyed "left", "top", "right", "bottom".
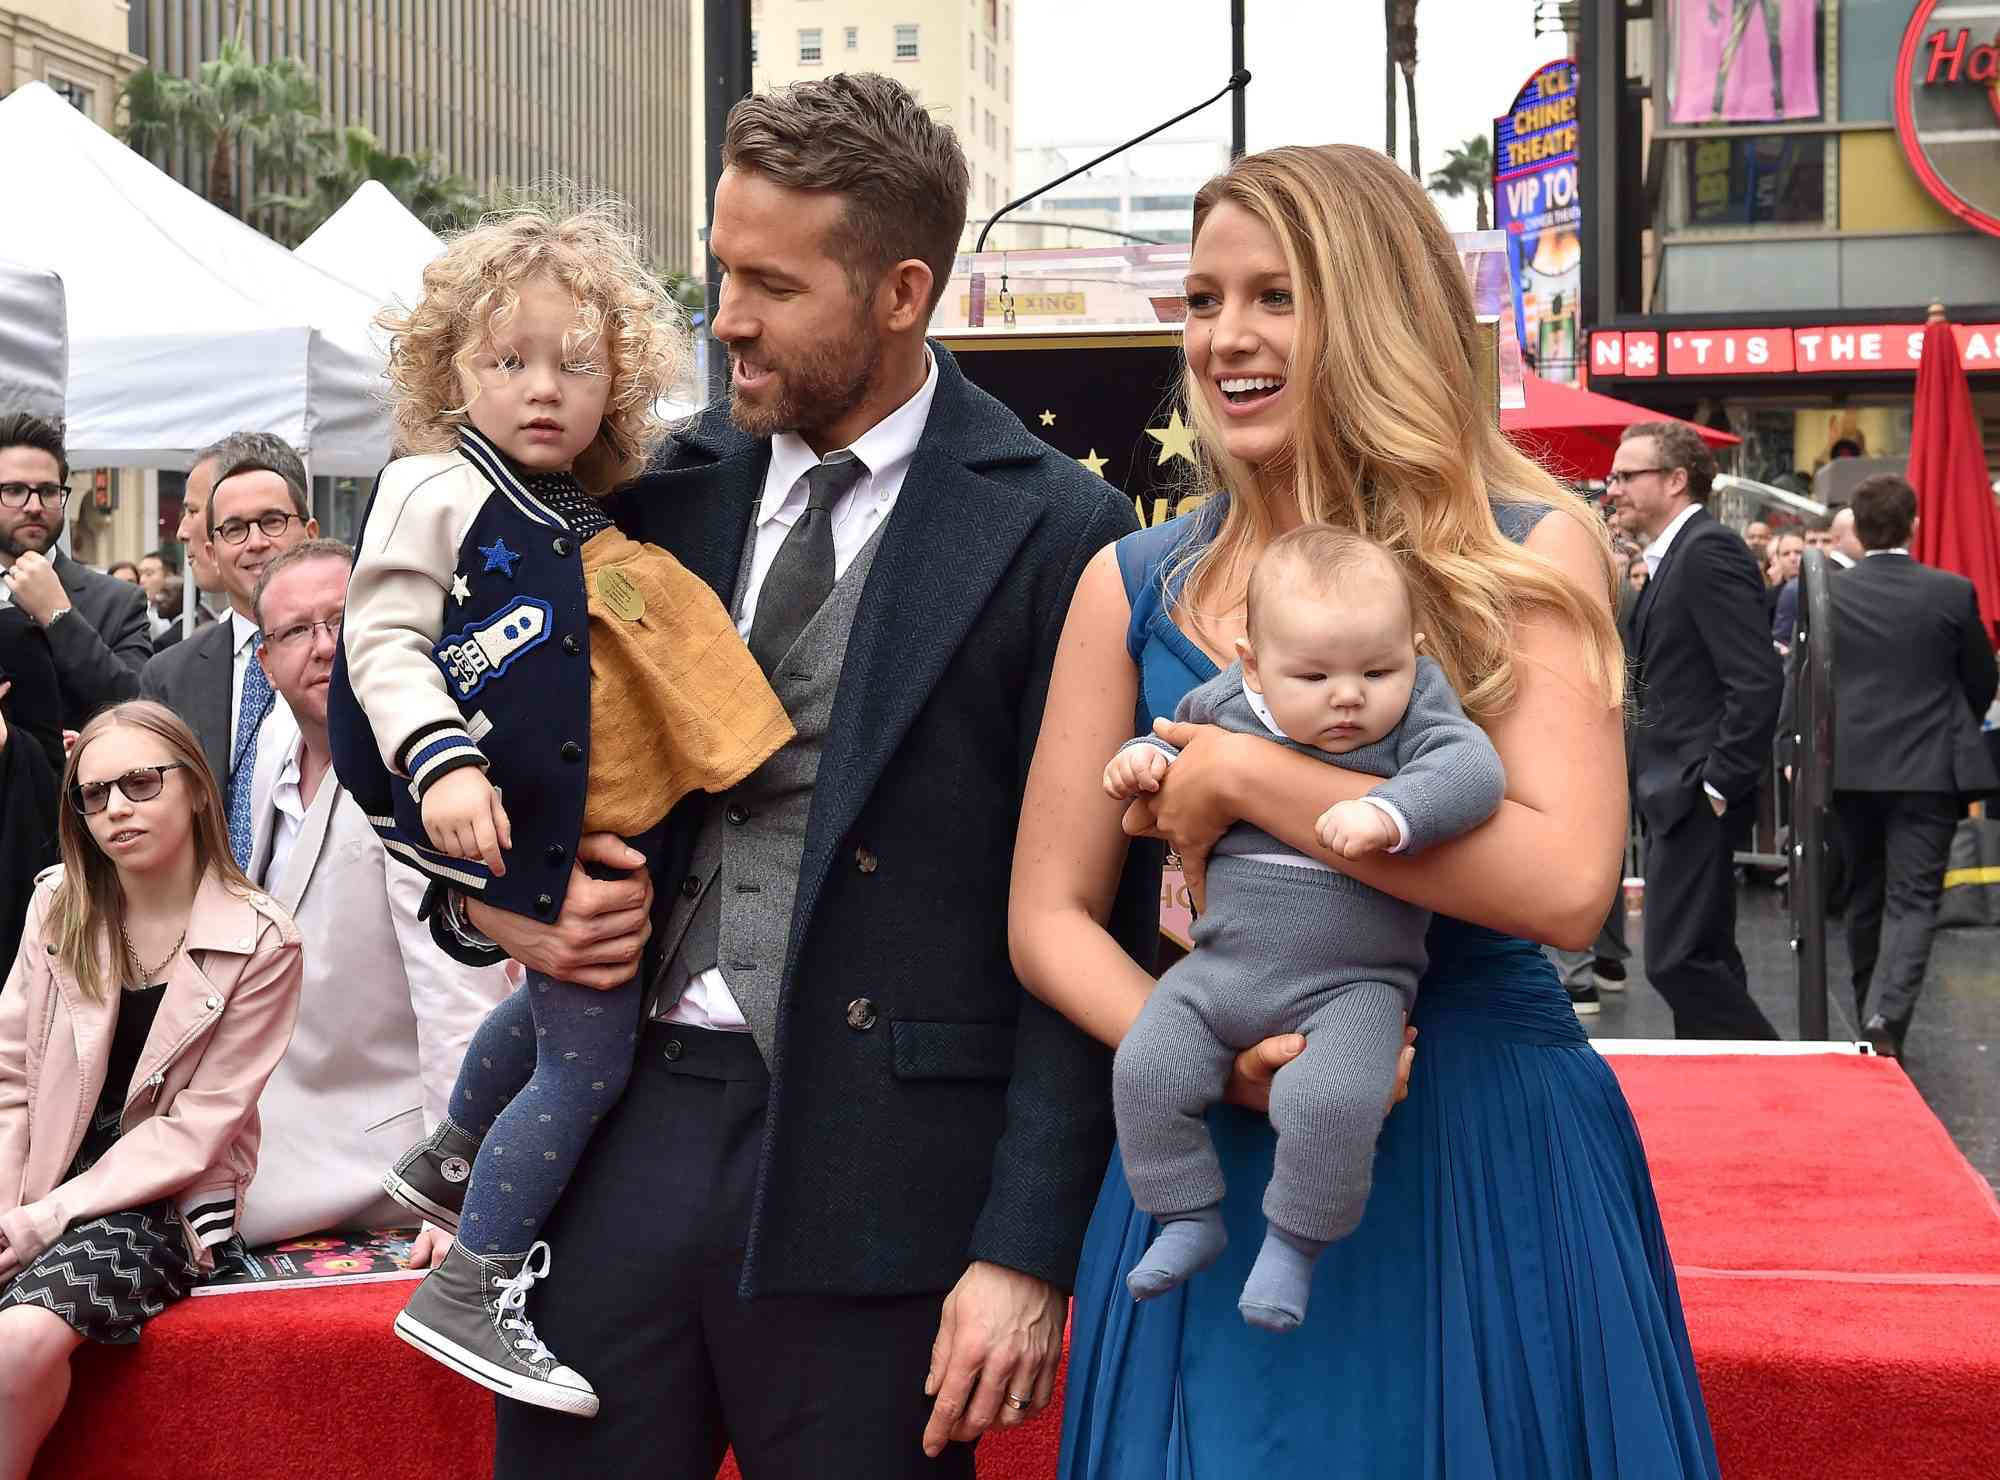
[{"left": 1790, "top": 550, "right": 1834, "bottom": 1040}]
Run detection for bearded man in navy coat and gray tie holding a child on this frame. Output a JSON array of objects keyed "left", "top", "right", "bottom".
[{"left": 440, "top": 74, "right": 1158, "bottom": 1480}]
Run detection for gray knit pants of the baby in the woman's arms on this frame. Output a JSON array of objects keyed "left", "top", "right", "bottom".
[{"left": 1112, "top": 854, "right": 1430, "bottom": 1242}]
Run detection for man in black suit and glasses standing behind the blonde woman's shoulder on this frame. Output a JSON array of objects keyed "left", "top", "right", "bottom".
[{"left": 1606, "top": 422, "right": 1784, "bottom": 1038}]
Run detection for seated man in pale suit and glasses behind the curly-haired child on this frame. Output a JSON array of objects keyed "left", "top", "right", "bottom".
[{"left": 238, "top": 540, "right": 512, "bottom": 1264}]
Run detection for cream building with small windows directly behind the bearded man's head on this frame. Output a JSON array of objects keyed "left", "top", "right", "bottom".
[{"left": 750, "top": 0, "right": 1014, "bottom": 244}]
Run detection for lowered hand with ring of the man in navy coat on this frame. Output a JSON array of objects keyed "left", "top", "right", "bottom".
[{"left": 924, "top": 1262, "right": 1070, "bottom": 1458}]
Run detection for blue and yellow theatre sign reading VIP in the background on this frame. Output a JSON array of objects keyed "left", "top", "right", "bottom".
[{"left": 1494, "top": 58, "right": 1584, "bottom": 382}]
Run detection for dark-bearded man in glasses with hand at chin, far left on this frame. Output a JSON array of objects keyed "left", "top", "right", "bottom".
[{"left": 0, "top": 412, "right": 152, "bottom": 730}]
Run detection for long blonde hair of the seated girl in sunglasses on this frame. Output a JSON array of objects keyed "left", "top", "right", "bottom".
[{"left": 48, "top": 698, "right": 254, "bottom": 1000}]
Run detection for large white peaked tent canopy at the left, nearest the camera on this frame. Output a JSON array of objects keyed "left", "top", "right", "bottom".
[{"left": 0, "top": 82, "right": 390, "bottom": 476}]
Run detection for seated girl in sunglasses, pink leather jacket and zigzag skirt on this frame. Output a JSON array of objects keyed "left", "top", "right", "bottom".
[{"left": 0, "top": 700, "right": 300, "bottom": 1480}]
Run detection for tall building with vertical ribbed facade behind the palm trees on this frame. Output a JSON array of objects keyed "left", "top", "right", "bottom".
[{"left": 125, "top": 0, "right": 702, "bottom": 268}]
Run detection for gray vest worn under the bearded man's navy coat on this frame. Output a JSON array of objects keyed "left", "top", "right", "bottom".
[{"left": 656, "top": 520, "right": 888, "bottom": 1064}]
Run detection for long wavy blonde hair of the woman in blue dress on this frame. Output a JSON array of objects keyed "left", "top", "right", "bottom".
[{"left": 1170, "top": 144, "right": 1624, "bottom": 724}]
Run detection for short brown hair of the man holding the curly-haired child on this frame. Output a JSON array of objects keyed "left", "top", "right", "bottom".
[{"left": 722, "top": 72, "right": 972, "bottom": 308}]
